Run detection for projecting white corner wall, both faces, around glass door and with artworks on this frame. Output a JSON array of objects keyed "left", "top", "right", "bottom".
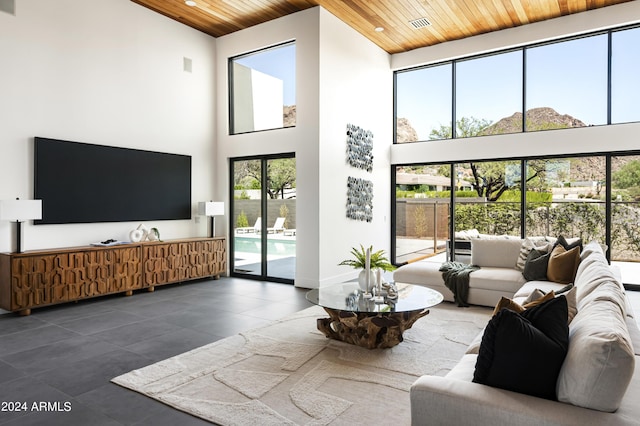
[{"left": 216, "top": 7, "right": 392, "bottom": 288}]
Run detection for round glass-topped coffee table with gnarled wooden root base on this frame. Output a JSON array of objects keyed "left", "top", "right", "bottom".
[{"left": 306, "top": 282, "right": 443, "bottom": 349}]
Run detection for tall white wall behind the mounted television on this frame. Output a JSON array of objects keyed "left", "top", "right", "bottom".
[{"left": 0, "top": 0, "right": 216, "bottom": 251}]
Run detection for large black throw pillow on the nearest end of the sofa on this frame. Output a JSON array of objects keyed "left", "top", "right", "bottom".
[{"left": 473, "top": 295, "right": 569, "bottom": 400}]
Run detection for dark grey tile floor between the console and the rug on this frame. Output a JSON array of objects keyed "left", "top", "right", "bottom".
[{"left": 0, "top": 278, "right": 311, "bottom": 426}]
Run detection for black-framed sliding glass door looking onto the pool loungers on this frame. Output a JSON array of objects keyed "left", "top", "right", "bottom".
[{"left": 230, "top": 154, "right": 297, "bottom": 284}]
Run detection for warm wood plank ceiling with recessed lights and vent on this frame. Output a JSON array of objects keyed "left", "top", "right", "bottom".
[{"left": 131, "top": 0, "right": 629, "bottom": 53}]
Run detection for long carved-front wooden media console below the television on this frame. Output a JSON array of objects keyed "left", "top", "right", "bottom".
[{"left": 0, "top": 237, "right": 227, "bottom": 315}]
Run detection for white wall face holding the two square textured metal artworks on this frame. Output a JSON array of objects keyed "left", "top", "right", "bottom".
[{"left": 319, "top": 9, "right": 393, "bottom": 285}]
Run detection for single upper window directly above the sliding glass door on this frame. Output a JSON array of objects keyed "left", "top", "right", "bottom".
[{"left": 229, "top": 42, "right": 296, "bottom": 134}]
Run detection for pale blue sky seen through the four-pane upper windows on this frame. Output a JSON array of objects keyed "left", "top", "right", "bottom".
[{"left": 397, "top": 28, "right": 640, "bottom": 140}]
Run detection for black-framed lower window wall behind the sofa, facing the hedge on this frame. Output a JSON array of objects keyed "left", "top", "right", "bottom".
[{"left": 391, "top": 152, "right": 640, "bottom": 285}]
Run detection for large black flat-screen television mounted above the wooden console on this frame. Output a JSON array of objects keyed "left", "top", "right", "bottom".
[{"left": 34, "top": 137, "right": 191, "bottom": 224}]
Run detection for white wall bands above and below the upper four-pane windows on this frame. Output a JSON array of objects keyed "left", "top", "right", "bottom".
[{"left": 391, "top": 1, "right": 640, "bottom": 164}]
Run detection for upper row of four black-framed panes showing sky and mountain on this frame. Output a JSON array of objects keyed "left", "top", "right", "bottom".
[{"left": 394, "top": 27, "right": 640, "bottom": 143}]
